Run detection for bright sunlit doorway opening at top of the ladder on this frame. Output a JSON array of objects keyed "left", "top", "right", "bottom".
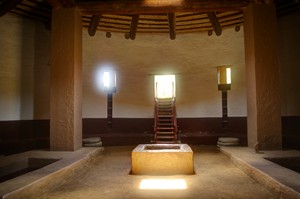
[{"left": 154, "top": 75, "right": 176, "bottom": 99}]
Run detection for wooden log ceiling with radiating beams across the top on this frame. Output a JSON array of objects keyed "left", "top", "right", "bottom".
[{"left": 0, "top": 0, "right": 299, "bottom": 39}]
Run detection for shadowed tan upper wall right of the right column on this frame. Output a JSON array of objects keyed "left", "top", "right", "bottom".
[{"left": 278, "top": 10, "right": 300, "bottom": 116}]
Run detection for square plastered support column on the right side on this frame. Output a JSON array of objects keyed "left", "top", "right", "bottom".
[{"left": 244, "top": 3, "right": 282, "bottom": 150}]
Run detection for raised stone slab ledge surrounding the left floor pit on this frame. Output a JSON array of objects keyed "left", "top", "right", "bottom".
[{"left": 0, "top": 147, "right": 104, "bottom": 199}]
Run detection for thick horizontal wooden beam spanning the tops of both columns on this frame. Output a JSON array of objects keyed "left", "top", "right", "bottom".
[{"left": 76, "top": 0, "right": 252, "bottom": 15}]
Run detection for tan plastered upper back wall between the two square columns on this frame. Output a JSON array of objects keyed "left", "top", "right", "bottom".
[{"left": 83, "top": 29, "right": 247, "bottom": 118}]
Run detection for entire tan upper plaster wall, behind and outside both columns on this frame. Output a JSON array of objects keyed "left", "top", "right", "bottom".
[{"left": 0, "top": 12, "right": 300, "bottom": 121}]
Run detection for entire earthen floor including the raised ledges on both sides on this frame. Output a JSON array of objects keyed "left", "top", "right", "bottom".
[{"left": 0, "top": 145, "right": 300, "bottom": 199}]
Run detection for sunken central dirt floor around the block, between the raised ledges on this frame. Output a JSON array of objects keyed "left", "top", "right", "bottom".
[{"left": 32, "top": 146, "right": 277, "bottom": 199}]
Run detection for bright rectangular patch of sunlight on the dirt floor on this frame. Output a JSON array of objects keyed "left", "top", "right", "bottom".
[{"left": 139, "top": 179, "right": 187, "bottom": 189}]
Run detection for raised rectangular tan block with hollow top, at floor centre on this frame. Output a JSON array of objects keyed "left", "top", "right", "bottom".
[{"left": 131, "top": 144, "right": 194, "bottom": 175}]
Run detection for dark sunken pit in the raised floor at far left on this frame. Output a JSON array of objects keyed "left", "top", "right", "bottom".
[{"left": 0, "top": 158, "right": 60, "bottom": 183}]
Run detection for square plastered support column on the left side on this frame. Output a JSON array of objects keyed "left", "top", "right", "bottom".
[{"left": 50, "top": 8, "right": 82, "bottom": 151}]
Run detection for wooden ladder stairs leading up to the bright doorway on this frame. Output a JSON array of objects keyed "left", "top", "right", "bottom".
[{"left": 154, "top": 98, "right": 179, "bottom": 143}]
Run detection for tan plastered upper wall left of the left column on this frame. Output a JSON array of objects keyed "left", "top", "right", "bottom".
[{"left": 0, "top": 14, "right": 50, "bottom": 120}]
